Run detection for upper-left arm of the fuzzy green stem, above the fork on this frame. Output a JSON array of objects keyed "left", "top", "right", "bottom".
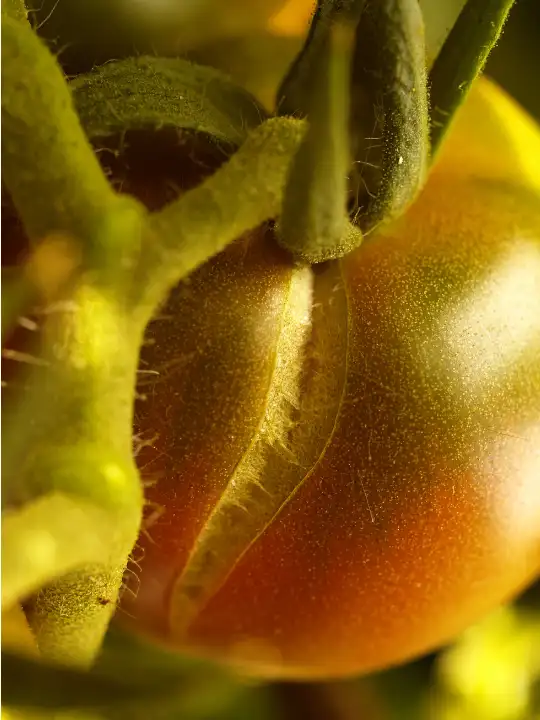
[{"left": 2, "top": 17, "right": 129, "bottom": 249}]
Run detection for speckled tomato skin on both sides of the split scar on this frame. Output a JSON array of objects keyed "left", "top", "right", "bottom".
[{"left": 120, "top": 85, "right": 540, "bottom": 678}]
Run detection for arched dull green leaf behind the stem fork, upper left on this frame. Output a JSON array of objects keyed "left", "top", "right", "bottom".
[{"left": 71, "top": 57, "right": 266, "bottom": 146}]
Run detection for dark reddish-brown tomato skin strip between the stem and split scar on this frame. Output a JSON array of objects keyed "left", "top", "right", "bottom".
[{"left": 124, "top": 228, "right": 298, "bottom": 636}]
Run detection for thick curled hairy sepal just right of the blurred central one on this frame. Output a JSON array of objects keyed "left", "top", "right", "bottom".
[{"left": 351, "top": 0, "right": 429, "bottom": 231}]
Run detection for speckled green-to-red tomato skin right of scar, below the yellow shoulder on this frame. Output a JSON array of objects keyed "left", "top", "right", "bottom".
[{"left": 179, "top": 174, "right": 540, "bottom": 677}]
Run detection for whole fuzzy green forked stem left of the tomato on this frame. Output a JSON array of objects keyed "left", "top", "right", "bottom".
[{"left": 2, "top": 0, "right": 305, "bottom": 666}]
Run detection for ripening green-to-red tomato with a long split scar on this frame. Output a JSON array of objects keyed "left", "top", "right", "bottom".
[{"left": 123, "top": 81, "right": 540, "bottom": 678}]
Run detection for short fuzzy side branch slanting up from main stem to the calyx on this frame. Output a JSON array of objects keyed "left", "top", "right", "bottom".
[{"left": 139, "top": 118, "right": 306, "bottom": 319}]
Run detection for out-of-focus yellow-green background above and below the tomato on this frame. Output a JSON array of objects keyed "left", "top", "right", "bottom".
[{"left": 5, "top": 0, "right": 540, "bottom": 720}]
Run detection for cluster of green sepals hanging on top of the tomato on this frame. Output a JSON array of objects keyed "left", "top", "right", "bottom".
[{"left": 277, "top": 0, "right": 513, "bottom": 263}]
